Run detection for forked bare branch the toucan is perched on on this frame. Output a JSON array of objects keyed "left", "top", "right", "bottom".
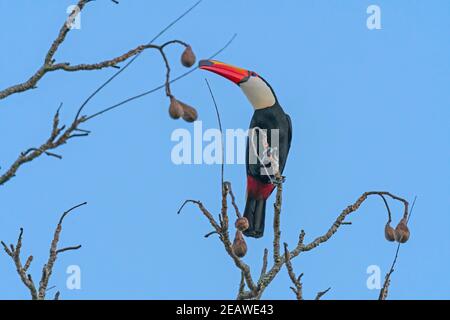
[{"left": 178, "top": 80, "right": 408, "bottom": 300}]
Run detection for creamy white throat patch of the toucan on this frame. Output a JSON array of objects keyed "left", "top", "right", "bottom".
[{"left": 239, "top": 76, "right": 276, "bottom": 110}]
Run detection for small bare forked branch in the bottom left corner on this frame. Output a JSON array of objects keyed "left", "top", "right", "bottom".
[{"left": 0, "top": 202, "right": 87, "bottom": 300}]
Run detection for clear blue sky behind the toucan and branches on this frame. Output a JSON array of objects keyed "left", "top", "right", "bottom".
[{"left": 0, "top": 0, "right": 450, "bottom": 299}]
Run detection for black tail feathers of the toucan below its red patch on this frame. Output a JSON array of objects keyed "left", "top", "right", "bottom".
[{"left": 244, "top": 195, "right": 266, "bottom": 238}]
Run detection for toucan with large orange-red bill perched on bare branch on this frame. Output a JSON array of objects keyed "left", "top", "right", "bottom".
[{"left": 199, "top": 60, "right": 292, "bottom": 238}]
